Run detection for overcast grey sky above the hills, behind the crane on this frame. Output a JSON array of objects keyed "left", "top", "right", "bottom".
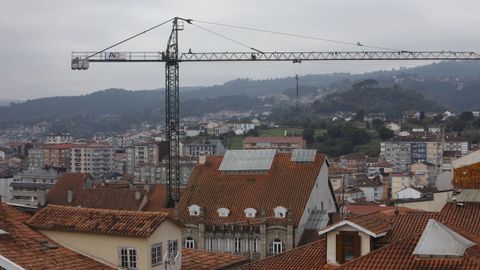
[{"left": 0, "top": 0, "right": 480, "bottom": 99}]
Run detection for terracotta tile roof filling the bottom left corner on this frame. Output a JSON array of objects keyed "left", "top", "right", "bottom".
[{"left": 0, "top": 203, "right": 114, "bottom": 270}]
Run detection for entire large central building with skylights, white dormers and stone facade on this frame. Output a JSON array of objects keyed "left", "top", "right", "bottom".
[{"left": 178, "top": 149, "right": 337, "bottom": 258}]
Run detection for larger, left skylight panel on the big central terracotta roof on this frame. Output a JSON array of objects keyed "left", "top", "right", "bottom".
[{"left": 219, "top": 149, "right": 276, "bottom": 171}]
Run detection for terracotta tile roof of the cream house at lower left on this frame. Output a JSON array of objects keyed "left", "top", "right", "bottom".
[{"left": 27, "top": 205, "right": 180, "bottom": 237}]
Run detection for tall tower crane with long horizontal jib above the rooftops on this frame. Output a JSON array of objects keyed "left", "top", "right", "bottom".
[{"left": 71, "top": 17, "right": 480, "bottom": 207}]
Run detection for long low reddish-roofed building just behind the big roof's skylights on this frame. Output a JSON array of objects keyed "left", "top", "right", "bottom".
[{"left": 243, "top": 137, "right": 306, "bottom": 153}]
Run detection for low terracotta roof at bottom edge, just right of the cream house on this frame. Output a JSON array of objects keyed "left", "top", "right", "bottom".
[{"left": 182, "top": 248, "right": 248, "bottom": 270}]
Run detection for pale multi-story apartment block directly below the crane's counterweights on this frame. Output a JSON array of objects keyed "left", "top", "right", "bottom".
[{"left": 71, "top": 144, "right": 113, "bottom": 178}]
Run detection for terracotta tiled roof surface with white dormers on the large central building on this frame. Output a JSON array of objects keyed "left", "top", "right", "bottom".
[{"left": 179, "top": 154, "right": 325, "bottom": 226}]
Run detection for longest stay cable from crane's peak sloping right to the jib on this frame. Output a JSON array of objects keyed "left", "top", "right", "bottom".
[{"left": 192, "top": 20, "right": 399, "bottom": 51}]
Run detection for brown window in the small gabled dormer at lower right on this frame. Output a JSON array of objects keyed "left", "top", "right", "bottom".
[{"left": 336, "top": 231, "right": 361, "bottom": 263}]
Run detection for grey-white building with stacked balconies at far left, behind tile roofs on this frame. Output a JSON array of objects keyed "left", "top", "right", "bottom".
[{"left": 10, "top": 168, "right": 62, "bottom": 206}]
